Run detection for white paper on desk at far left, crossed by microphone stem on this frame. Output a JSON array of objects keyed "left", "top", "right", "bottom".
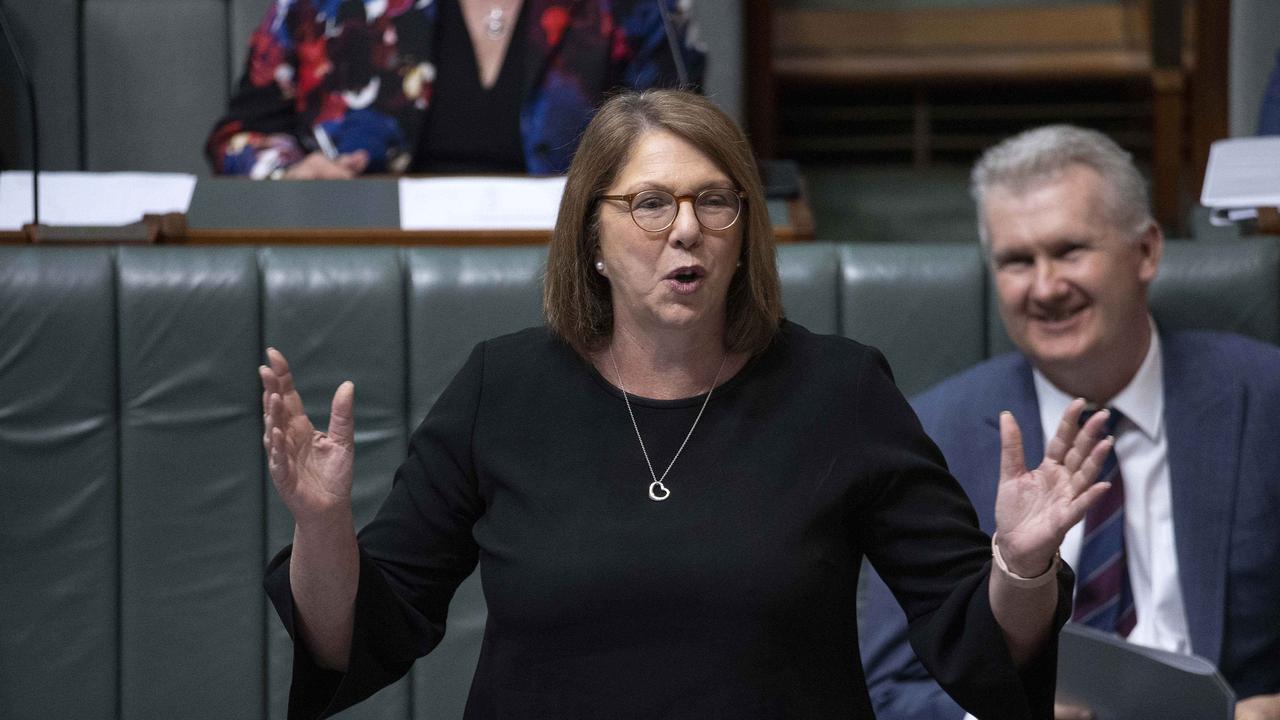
[{"left": 0, "top": 170, "right": 196, "bottom": 231}]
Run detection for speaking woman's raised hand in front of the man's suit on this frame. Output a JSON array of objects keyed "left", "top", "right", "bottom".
[{"left": 996, "top": 398, "right": 1115, "bottom": 578}]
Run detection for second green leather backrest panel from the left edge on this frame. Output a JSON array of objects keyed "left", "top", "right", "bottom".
[{"left": 116, "top": 247, "right": 265, "bottom": 720}]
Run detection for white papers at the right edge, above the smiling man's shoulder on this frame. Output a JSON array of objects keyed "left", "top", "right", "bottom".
[{"left": 1201, "top": 136, "right": 1280, "bottom": 209}]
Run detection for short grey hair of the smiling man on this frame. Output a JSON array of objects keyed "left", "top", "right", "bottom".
[{"left": 969, "top": 124, "right": 1152, "bottom": 247}]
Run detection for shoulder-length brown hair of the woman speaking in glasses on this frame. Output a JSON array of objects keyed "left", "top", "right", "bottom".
[{"left": 543, "top": 90, "right": 782, "bottom": 356}]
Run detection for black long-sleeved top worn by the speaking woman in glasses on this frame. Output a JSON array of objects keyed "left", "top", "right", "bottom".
[{"left": 266, "top": 323, "right": 1070, "bottom": 720}]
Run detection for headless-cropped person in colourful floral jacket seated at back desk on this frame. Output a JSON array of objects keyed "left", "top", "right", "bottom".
[{"left": 205, "top": 0, "right": 704, "bottom": 179}]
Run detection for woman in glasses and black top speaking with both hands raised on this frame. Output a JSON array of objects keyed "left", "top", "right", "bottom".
[{"left": 260, "top": 91, "right": 1110, "bottom": 719}]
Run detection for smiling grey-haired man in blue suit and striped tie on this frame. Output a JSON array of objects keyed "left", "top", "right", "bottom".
[{"left": 859, "top": 126, "right": 1280, "bottom": 720}]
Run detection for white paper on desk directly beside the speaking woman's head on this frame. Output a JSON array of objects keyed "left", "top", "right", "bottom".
[{"left": 399, "top": 176, "right": 564, "bottom": 231}]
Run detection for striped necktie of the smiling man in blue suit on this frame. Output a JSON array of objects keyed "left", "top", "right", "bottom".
[{"left": 1071, "top": 409, "right": 1138, "bottom": 637}]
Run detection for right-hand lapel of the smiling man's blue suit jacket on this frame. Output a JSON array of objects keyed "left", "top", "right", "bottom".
[{"left": 1161, "top": 334, "right": 1244, "bottom": 662}]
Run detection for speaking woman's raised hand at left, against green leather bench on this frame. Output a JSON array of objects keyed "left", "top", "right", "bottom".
[{"left": 257, "top": 347, "right": 356, "bottom": 525}]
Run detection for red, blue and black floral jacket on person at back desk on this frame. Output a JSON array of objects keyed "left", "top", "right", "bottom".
[{"left": 205, "top": 0, "right": 705, "bottom": 178}]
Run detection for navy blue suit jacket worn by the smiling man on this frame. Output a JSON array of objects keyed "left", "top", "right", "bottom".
[{"left": 859, "top": 332, "right": 1280, "bottom": 719}]
